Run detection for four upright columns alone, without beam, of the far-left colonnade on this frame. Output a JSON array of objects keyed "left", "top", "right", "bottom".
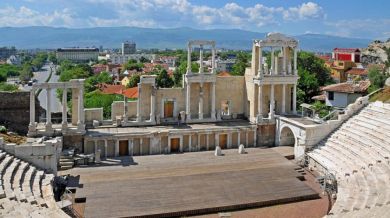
[{"left": 29, "top": 88, "right": 85, "bottom": 131}]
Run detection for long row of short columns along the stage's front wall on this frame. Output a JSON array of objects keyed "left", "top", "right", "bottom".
[{"left": 84, "top": 128, "right": 257, "bottom": 158}]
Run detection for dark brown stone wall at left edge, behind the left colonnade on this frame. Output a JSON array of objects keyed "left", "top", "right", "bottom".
[{"left": 0, "top": 92, "right": 44, "bottom": 135}]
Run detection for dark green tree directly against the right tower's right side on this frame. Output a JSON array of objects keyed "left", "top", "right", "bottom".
[{"left": 297, "top": 68, "right": 319, "bottom": 106}]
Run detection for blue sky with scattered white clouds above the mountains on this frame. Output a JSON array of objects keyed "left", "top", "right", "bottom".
[{"left": 0, "top": 0, "right": 390, "bottom": 39}]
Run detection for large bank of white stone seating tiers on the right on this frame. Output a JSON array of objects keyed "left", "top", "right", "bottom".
[{"left": 308, "top": 102, "right": 390, "bottom": 218}]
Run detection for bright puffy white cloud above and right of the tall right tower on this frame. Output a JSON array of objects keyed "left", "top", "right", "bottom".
[{"left": 283, "top": 2, "right": 326, "bottom": 21}]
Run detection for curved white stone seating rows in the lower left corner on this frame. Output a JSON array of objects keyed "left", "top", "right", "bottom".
[{"left": 0, "top": 151, "right": 69, "bottom": 218}]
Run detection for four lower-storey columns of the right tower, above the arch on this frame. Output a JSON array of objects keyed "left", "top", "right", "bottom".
[{"left": 257, "top": 83, "right": 297, "bottom": 119}]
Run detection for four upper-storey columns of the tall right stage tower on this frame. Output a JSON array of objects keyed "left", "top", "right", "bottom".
[{"left": 257, "top": 46, "right": 298, "bottom": 77}]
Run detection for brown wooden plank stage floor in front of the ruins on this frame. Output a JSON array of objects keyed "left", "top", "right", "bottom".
[{"left": 68, "top": 148, "right": 318, "bottom": 218}]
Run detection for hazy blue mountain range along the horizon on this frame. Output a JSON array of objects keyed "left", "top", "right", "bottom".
[{"left": 0, "top": 26, "right": 373, "bottom": 52}]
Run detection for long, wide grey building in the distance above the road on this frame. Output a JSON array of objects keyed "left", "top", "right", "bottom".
[{"left": 56, "top": 48, "right": 99, "bottom": 63}]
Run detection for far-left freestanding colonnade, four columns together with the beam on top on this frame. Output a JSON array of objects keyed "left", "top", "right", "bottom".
[{"left": 29, "top": 79, "right": 85, "bottom": 132}]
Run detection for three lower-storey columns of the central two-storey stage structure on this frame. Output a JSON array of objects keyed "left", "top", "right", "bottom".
[{"left": 186, "top": 82, "right": 215, "bottom": 120}]
